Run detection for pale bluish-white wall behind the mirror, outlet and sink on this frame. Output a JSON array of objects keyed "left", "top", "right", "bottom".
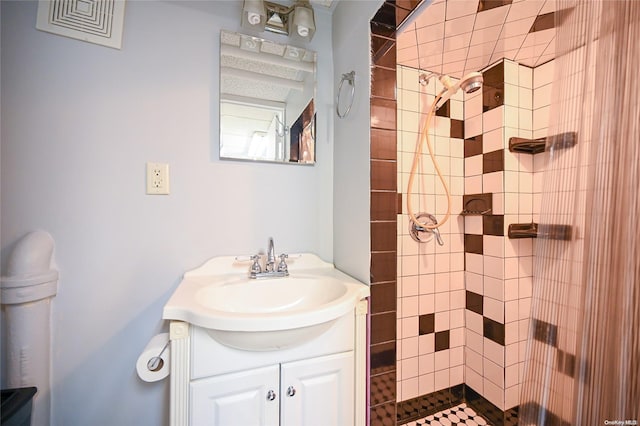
[{"left": 1, "top": 0, "right": 336, "bottom": 425}]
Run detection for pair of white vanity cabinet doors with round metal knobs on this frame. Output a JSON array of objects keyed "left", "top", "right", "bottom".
[{"left": 190, "top": 351, "right": 354, "bottom": 426}]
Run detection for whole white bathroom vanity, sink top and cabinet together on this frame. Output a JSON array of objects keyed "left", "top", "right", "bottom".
[{"left": 162, "top": 253, "right": 370, "bottom": 426}]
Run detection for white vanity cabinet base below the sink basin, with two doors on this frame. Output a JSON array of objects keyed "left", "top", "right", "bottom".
[{"left": 170, "top": 301, "right": 367, "bottom": 426}]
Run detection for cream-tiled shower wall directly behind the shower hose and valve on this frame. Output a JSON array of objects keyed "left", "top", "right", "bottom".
[{"left": 397, "top": 67, "right": 466, "bottom": 401}]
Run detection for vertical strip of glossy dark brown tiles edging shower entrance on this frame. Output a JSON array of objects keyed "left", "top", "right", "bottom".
[{"left": 369, "top": 0, "right": 418, "bottom": 426}]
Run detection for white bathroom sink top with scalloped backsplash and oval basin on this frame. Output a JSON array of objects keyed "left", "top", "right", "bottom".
[{"left": 163, "top": 254, "right": 369, "bottom": 351}]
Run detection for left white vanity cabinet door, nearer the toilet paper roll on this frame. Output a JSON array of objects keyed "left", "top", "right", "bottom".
[{"left": 189, "top": 365, "right": 281, "bottom": 426}]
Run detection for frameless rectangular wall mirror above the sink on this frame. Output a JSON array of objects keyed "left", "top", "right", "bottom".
[{"left": 220, "top": 30, "right": 316, "bottom": 164}]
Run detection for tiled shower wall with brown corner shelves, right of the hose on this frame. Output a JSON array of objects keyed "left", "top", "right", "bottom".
[{"left": 465, "top": 60, "right": 553, "bottom": 410}]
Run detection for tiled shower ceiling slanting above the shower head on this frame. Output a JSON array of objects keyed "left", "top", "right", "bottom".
[{"left": 397, "top": 0, "right": 556, "bottom": 78}]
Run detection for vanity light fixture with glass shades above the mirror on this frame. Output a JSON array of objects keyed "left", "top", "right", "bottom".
[{"left": 242, "top": 0, "right": 316, "bottom": 41}]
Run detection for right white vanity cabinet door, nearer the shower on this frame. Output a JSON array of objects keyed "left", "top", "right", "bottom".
[{"left": 280, "top": 351, "right": 354, "bottom": 426}]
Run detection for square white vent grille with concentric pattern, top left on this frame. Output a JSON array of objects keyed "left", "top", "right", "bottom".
[{"left": 36, "top": 0, "right": 125, "bottom": 49}]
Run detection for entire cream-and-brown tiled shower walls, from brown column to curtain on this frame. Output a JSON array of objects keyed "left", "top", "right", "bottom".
[{"left": 397, "top": 60, "right": 553, "bottom": 410}]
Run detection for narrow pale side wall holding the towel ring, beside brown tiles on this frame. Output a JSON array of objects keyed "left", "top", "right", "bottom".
[{"left": 333, "top": 0, "right": 383, "bottom": 283}]
